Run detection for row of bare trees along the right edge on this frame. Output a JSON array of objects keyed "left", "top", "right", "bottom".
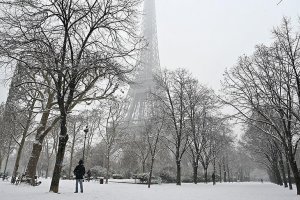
[{"left": 224, "top": 18, "right": 300, "bottom": 195}]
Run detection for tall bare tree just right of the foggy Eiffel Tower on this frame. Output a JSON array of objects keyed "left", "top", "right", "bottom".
[{"left": 155, "top": 69, "right": 190, "bottom": 185}]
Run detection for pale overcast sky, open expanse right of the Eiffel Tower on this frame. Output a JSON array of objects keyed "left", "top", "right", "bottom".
[{"left": 0, "top": 0, "right": 300, "bottom": 102}]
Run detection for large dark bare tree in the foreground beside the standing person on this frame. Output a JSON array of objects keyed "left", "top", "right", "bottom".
[{"left": 0, "top": 0, "right": 140, "bottom": 193}]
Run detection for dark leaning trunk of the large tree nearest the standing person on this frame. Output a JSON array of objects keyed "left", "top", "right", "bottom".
[{"left": 50, "top": 113, "right": 69, "bottom": 193}]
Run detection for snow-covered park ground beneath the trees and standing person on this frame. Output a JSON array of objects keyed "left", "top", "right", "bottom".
[{"left": 0, "top": 180, "right": 300, "bottom": 200}]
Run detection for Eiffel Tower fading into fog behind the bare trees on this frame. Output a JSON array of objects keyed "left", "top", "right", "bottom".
[{"left": 126, "top": 0, "right": 160, "bottom": 124}]
